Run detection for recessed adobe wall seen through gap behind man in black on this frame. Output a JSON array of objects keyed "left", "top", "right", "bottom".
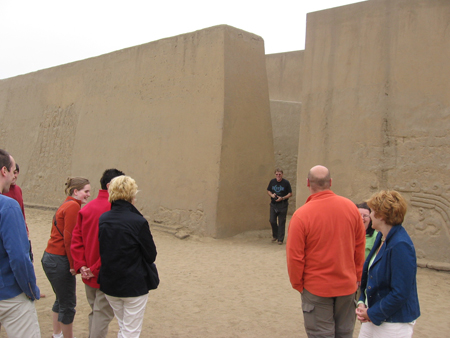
[{"left": 266, "top": 51, "right": 303, "bottom": 214}]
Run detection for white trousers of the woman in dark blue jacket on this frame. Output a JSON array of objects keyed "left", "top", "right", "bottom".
[{"left": 358, "top": 322, "right": 415, "bottom": 338}]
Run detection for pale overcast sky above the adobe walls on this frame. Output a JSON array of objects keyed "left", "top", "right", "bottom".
[{"left": 0, "top": 0, "right": 361, "bottom": 79}]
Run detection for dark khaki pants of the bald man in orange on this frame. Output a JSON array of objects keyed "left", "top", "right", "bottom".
[{"left": 302, "top": 289, "right": 356, "bottom": 338}]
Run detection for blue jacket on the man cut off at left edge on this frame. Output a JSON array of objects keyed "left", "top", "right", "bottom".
[{"left": 0, "top": 194, "right": 40, "bottom": 300}]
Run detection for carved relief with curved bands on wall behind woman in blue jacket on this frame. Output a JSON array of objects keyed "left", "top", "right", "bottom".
[{"left": 394, "top": 181, "right": 450, "bottom": 262}]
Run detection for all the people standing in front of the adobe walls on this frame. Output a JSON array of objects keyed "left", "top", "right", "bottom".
[{"left": 0, "top": 149, "right": 420, "bottom": 338}]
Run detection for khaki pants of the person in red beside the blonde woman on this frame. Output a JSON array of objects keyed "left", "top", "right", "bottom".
[{"left": 84, "top": 284, "right": 114, "bottom": 338}]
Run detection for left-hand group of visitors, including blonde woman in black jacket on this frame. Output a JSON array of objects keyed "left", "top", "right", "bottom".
[{"left": 0, "top": 149, "right": 159, "bottom": 338}]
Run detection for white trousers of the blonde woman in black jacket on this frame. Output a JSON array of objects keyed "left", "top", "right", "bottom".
[{"left": 106, "top": 293, "right": 148, "bottom": 338}]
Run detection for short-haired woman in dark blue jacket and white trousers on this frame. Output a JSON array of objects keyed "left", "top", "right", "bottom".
[{"left": 356, "top": 190, "right": 420, "bottom": 338}]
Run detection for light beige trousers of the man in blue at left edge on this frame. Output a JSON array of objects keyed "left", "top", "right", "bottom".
[{"left": 0, "top": 293, "right": 41, "bottom": 338}]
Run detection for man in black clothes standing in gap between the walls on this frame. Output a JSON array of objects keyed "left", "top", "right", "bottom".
[{"left": 267, "top": 169, "right": 292, "bottom": 245}]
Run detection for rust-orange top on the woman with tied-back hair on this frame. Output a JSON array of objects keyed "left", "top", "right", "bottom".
[{"left": 45, "top": 196, "right": 81, "bottom": 269}]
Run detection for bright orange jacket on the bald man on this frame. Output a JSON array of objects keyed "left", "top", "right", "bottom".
[{"left": 286, "top": 190, "right": 366, "bottom": 297}]
